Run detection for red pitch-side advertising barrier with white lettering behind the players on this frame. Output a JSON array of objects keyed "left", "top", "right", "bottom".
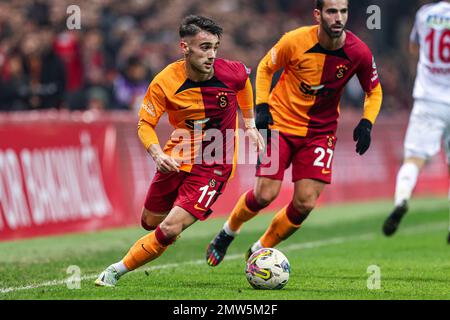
[{"left": 0, "top": 111, "right": 448, "bottom": 240}]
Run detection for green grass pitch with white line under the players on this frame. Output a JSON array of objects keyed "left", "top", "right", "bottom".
[{"left": 0, "top": 198, "right": 450, "bottom": 300}]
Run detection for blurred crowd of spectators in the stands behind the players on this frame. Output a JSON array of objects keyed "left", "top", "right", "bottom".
[{"left": 0, "top": 0, "right": 425, "bottom": 112}]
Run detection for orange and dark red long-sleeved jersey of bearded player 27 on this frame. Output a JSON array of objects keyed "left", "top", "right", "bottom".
[{"left": 256, "top": 25, "right": 382, "bottom": 136}]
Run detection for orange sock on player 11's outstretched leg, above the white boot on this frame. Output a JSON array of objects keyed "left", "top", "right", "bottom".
[{"left": 123, "top": 228, "right": 173, "bottom": 271}]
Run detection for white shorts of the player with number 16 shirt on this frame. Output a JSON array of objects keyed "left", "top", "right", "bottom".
[{"left": 404, "top": 99, "right": 450, "bottom": 163}]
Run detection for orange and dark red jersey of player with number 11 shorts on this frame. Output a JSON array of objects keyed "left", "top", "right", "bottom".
[{"left": 139, "top": 59, "right": 253, "bottom": 180}]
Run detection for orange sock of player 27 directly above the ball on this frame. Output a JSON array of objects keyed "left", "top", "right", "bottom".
[{"left": 259, "top": 206, "right": 301, "bottom": 248}]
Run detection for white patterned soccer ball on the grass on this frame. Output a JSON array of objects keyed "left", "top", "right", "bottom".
[{"left": 245, "top": 248, "right": 291, "bottom": 290}]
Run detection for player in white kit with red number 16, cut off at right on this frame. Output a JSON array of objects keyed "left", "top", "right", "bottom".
[{"left": 383, "top": 1, "right": 450, "bottom": 244}]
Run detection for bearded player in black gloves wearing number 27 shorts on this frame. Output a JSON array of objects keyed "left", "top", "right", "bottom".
[{"left": 206, "top": 0, "right": 382, "bottom": 266}]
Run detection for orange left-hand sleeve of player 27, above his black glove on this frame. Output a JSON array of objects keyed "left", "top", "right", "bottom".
[{"left": 256, "top": 33, "right": 292, "bottom": 104}]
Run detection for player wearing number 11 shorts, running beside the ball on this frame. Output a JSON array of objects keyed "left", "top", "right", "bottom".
[{"left": 95, "top": 16, "right": 264, "bottom": 286}]
